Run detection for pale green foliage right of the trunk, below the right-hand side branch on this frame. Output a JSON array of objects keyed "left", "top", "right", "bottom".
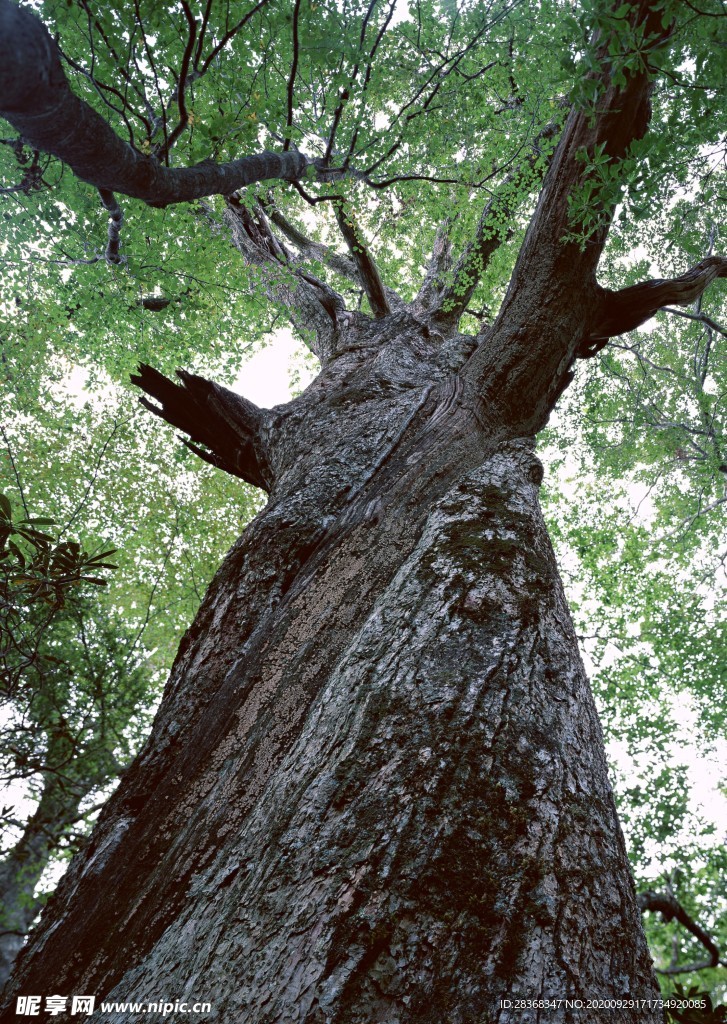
[{"left": 542, "top": 264, "right": 727, "bottom": 991}]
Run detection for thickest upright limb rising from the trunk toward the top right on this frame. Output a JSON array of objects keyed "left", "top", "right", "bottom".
[{"left": 465, "top": 0, "right": 672, "bottom": 433}]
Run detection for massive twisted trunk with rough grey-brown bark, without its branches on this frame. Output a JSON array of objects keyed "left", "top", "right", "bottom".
[{"left": 0, "top": 312, "right": 660, "bottom": 1024}]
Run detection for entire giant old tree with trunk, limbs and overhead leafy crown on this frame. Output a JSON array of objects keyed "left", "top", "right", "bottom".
[{"left": 0, "top": 0, "right": 727, "bottom": 1022}]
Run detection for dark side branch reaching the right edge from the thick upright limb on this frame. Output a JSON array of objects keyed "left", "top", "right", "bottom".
[{"left": 578, "top": 256, "right": 727, "bottom": 358}]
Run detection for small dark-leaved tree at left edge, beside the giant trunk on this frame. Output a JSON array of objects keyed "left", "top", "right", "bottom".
[{"left": 0, "top": 495, "right": 151, "bottom": 984}]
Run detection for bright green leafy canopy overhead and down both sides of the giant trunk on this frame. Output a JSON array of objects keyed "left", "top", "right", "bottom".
[{"left": 0, "top": 0, "right": 727, "bottom": 999}]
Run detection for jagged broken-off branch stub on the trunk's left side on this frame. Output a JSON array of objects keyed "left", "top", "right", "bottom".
[{"left": 131, "top": 362, "right": 272, "bottom": 490}]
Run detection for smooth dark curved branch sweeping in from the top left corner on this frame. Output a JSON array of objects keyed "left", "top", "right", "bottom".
[{"left": 0, "top": 0, "right": 309, "bottom": 206}]
